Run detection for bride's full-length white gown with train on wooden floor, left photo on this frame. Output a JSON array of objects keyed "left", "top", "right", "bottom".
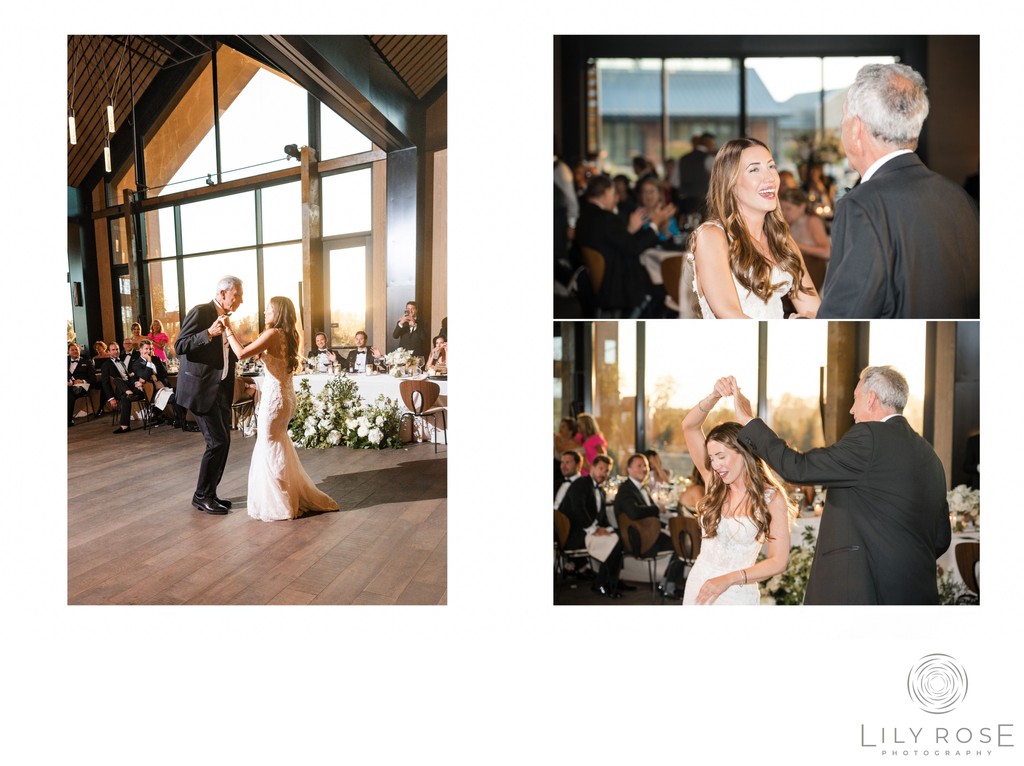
[{"left": 247, "top": 346, "right": 339, "bottom": 521}]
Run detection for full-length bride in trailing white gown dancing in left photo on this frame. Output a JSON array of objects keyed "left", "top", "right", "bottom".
[{"left": 221, "top": 296, "right": 339, "bottom": 521}]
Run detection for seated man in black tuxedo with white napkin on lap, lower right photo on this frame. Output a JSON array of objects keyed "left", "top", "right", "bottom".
[{"left": 558, "top": 453, "right": 632, "bottom": 598}]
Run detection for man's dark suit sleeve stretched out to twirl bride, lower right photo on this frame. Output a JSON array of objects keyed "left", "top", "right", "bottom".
[{"left": 739, "top": 418, "right": 874, "bottom": 486}]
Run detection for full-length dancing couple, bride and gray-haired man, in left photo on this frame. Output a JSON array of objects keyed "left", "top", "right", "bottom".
[{"left": 174, "top": 276, "right": 339, "bottom": 521}]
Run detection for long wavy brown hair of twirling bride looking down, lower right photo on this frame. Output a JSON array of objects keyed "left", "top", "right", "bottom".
[{"left": 696, "top": 422, "right": 796, "bottom": 543}]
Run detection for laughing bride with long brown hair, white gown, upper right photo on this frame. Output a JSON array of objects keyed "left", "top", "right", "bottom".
[{"left": 687, "top": 138, "right": 821, "bottom": 320}]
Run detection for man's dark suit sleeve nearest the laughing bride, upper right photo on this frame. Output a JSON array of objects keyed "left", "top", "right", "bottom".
[{"left": 818, "top": 193, "right": 895, "bottom": 320}]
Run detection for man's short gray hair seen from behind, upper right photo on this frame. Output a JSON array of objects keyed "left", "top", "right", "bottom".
[{"left": 846, "top": 63, "right": 928, "bottom": 150}]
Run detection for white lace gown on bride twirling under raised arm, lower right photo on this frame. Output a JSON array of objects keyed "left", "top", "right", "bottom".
[{"left": 683, "top": 516, "right": 761, "bottom": 606}]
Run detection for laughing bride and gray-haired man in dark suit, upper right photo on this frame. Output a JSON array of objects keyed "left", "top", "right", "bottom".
[{"left": 680, "top": 63, "right": 980, "bottom": 320}]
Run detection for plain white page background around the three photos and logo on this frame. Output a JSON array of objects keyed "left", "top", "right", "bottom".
[{"left": 0, "top": 0, "right": 1024, "bottom": 764}]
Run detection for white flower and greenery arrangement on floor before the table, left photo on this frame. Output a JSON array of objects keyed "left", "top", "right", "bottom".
[{"left": 289, "top": 376, "right": 401, "bottom": 450}]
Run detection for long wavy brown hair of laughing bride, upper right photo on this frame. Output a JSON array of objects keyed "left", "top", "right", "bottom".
[{"left": 689, "top": 138, "right": 813, "bottom": 303}]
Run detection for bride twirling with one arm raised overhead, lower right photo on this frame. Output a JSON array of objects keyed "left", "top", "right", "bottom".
[{"left": 683, "top": 378, "right": 794, "bottom": 605}]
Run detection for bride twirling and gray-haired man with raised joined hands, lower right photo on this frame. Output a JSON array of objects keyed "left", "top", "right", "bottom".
[{"left": 683, "top": 367, "right": 950, "bottom": 604}]
